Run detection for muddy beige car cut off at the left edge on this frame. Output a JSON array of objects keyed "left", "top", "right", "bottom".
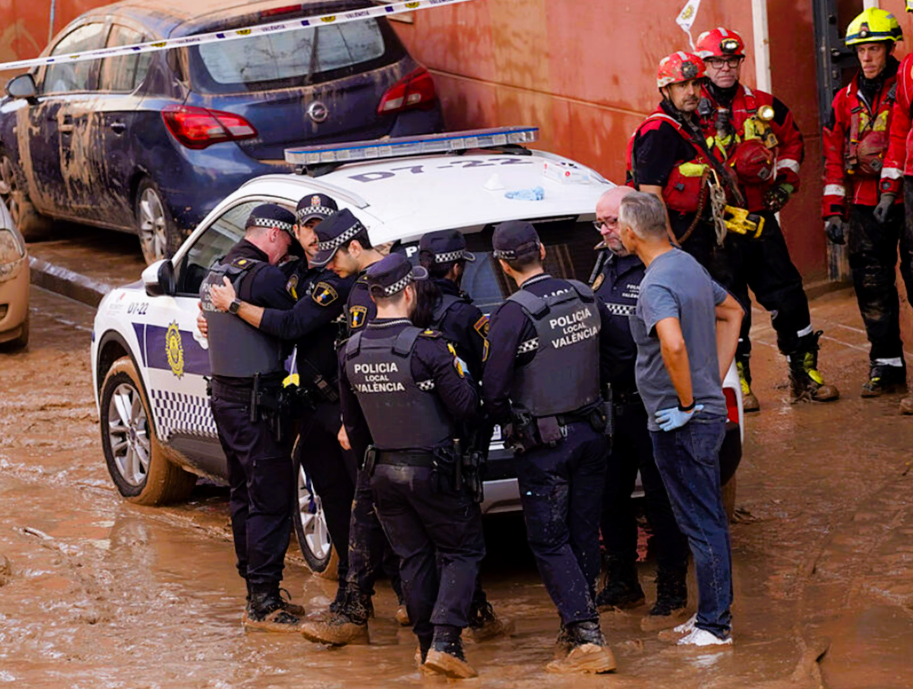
[{"left": 0, "top": 201, "right": 29, "bottom": 351}]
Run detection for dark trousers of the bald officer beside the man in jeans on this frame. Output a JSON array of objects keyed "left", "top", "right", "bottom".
[{"left": 600, "top": 396, "right": 690, "bottom": 571}]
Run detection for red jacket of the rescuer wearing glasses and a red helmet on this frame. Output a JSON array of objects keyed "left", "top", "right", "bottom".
[{"left": 701, "top": 84, "right": 805, "bottom": 212}]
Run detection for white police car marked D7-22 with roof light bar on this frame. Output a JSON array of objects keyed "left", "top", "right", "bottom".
[{"left": 92, "top": 127, "right": 742, "bottom": 572}]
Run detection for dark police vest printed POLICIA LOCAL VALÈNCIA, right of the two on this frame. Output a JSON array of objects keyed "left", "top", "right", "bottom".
[{"left": 508, "top": 280, "right": 602, "bottom": 418}]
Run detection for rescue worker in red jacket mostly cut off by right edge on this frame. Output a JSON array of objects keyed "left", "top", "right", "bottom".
[{"left": 866, "top": 0, "right": 913, "bottom": 414}]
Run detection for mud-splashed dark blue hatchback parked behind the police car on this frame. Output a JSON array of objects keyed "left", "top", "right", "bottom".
[{"left": 0, "top": 0, "right": 443, "bottom": 262}]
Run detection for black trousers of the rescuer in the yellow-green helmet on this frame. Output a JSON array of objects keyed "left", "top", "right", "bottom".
[{"left": 847, "top": 198, "right": 913, "bottom": 362}]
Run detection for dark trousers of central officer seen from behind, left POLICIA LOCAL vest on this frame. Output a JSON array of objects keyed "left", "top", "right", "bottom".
[{"left": 371, "top": 464, "right": 485, "bottom": 648}]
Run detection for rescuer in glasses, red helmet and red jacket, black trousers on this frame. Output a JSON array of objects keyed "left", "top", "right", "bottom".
[{"left": 697, "top": 28, "right": 839, "bottom": 411}]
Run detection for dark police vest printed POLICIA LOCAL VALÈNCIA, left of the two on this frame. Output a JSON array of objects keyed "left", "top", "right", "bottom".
[{"left": 346, "top": 326, "right": 454, "bottom": 450}]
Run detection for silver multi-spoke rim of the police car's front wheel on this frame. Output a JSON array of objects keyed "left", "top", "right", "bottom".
[{"left": 108, "top": 383, "right": 150, "bottom": 486}]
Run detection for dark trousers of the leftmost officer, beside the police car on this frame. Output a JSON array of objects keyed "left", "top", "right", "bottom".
[{"left": 210, "top": 381, "right": 295, "bottom": 585}]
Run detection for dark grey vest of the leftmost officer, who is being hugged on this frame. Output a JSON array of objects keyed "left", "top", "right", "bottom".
[{"left": 200, "top": 258, "right": 284, "bottom": 378}]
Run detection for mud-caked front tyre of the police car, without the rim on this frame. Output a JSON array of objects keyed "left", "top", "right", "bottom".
[{"left": 99, "top": 356, "right": 196, "bottom": 505}]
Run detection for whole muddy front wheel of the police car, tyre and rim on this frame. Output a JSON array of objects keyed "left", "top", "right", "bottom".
[{"left": 99, "top": 357, "right": 196, "bottom": 505}]
